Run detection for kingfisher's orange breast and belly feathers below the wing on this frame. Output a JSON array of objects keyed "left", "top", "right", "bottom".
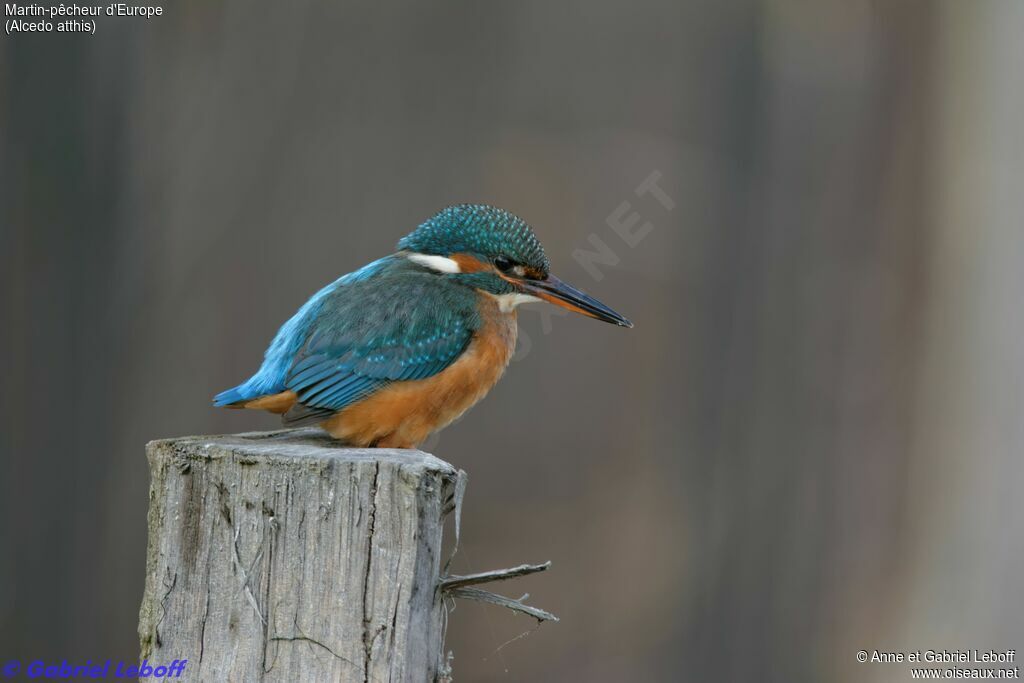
[{"left": 323, "top": 294, "right": 517, "bottom": 447}]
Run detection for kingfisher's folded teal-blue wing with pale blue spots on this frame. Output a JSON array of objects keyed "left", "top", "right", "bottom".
[{"left": 284, "top": 271, "right": 480, "bottom": 426}]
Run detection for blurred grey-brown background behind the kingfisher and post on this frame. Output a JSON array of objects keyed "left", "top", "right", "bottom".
[{"left": 0, "top": 0, "right": 1024, "bottom": 683}]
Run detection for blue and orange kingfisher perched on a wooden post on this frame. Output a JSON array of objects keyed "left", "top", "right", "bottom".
[{"left": 214, "top": 204, "right": 633, "bottom": 449}]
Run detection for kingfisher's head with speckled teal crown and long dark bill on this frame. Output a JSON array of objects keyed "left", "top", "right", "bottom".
[{"left": 398, "top": 204, "right": 633, "bottom": 328}]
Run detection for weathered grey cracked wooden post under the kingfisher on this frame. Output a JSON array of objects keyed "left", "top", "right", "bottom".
[{"left": 139, "top": 430, "right": 464, "bottom": 682}]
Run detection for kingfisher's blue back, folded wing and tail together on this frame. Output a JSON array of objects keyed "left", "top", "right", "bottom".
[{"left": 214, "top": 256, "right": 481, "bottom": 425}]
